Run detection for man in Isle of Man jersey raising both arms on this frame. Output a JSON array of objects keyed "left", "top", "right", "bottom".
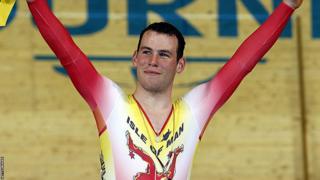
[{"left": 27, "top": 0, "right": 302, "bottom": 180}]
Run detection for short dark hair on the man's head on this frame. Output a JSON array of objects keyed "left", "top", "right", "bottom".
[{"left": 137, "top": 22, "right": 186, "bottom": 60}]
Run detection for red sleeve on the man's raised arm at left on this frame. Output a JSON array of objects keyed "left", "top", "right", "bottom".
[{"left": 28, "top": 0, "right": 101, "bottom": 109}]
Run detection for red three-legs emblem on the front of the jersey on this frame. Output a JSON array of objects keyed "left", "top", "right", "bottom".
[{"left": 126, "top": 131, "right": 183, "bottom": 180}]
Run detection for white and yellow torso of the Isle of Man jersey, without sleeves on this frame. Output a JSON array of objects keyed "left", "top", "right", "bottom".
[{"left": 100, "top": 88, "right": 201, "bottom": 179}]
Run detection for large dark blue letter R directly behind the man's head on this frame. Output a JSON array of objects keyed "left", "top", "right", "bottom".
[{"left": 128, "top": 0, "right": 201, "bottom": 36}]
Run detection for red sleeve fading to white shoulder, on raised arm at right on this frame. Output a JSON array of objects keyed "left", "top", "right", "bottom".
[{"left": 186, "top": 3, "right": 294, "bottom": 138}]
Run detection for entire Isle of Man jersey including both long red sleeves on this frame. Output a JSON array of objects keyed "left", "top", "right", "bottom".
[{"left": 29, "top": 0, "right": 293, "bottom": 180}]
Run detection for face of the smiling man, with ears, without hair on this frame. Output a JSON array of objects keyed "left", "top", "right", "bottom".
[{"left": 133, "top": 30, "right": 185, "bottom": 92}]
